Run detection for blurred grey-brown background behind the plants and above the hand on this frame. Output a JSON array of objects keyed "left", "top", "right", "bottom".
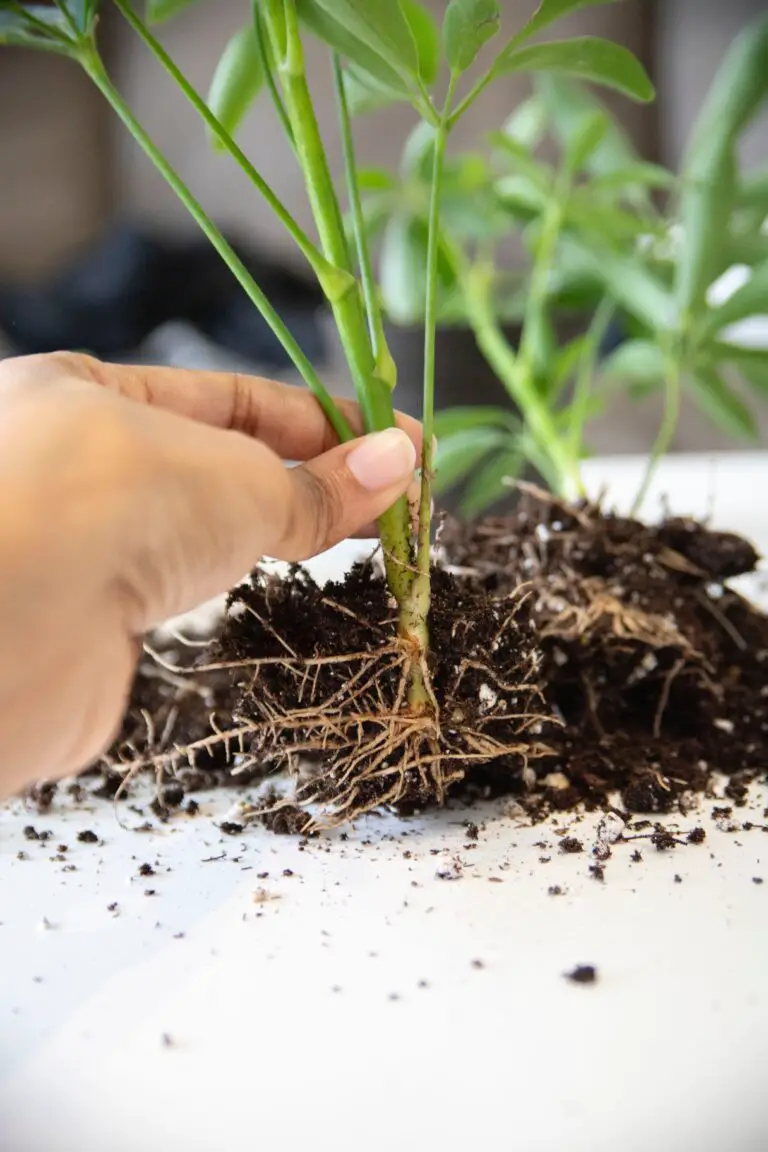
[{"left": 0, "top": 0, "right": 768, "bottom": 472}]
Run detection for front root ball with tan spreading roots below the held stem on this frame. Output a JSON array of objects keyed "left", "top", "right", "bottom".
[{"left": 188, "top": 564, "right": 554, "bottom": 824}]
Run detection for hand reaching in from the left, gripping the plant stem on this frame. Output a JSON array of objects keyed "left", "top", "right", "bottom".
[{"left": 0, "top": 353, "right": 420, "bottom": 794}]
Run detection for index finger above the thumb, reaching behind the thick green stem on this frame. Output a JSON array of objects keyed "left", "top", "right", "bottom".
[{"left": 24, "top": 353, "right": 421, "bottom": 461}]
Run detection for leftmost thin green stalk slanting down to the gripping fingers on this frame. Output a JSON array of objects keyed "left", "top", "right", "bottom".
[{"left": 81, "top": 46, "right": 355, "bottom": 440}]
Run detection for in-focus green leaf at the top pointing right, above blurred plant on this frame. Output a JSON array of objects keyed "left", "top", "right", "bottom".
[{"left": 493, "top": 36, "right": 655, "bottom": 104}]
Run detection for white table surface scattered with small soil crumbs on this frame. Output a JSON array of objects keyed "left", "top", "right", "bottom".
[{"left": 0, "top": 462, "right": 768, "bottom": 1152}]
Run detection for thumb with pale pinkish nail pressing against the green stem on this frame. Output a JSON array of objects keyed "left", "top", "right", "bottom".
[{"left": 264, "top": 429, "right": 417, "bottom": 560}]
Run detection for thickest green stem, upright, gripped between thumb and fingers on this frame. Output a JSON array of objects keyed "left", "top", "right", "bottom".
[{"left": 269, "top": 0, "right": 412, "bottom": 605}]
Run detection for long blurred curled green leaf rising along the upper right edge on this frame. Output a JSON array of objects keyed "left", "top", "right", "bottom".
[{"left": 676, "top": 15, "right": 768, "bottom": 316}]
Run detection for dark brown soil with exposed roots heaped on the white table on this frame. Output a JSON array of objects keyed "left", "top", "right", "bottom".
[{"left": 79, "top": 491, "right": 768, "bottom": 834}]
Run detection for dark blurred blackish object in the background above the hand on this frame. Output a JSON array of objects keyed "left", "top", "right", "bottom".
[{"left": 0, "top": 225, "right": 327, "bottom": 369}]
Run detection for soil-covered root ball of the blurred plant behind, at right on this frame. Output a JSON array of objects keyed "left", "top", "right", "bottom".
[{"left": 443, "top": 490, "right": 768, "bottom": 812}]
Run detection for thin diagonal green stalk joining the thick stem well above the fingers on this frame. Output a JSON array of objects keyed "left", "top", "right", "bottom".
[{"left": 114, "top": 0, "right": 350, "bottom": 300}]
